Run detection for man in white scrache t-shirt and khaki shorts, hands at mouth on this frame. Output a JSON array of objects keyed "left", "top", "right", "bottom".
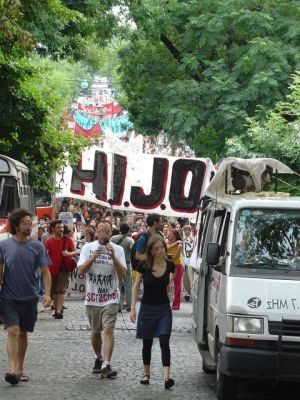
[{"left": 78, "top": 220, "right": 126, "bottom": 378}]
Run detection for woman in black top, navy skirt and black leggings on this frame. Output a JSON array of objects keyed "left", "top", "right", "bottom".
[{"left": 130, "top": 235, "right": 175, "bottom": 389}]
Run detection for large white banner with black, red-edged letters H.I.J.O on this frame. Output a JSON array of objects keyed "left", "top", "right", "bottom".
[{"left": 57, "top": 146, "right": 213, "bottom": 218}]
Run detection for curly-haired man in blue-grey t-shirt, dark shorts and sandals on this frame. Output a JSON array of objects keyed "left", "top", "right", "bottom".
[{"left": 0, "top": 208, "right": 51, "bottom": 385}]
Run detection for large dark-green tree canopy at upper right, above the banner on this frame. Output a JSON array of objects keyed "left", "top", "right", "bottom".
[{"left": 116, "top": 0, "right": 300, "bottom": 160}]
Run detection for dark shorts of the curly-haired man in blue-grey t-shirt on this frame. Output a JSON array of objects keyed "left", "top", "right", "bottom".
[{"left": 0, "top": 297, "right": 39, "bottom": 332}]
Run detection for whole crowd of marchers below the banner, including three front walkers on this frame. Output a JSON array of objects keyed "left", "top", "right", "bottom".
[{"left": 0, "top": 202, "right": 196, "bottom": 389}]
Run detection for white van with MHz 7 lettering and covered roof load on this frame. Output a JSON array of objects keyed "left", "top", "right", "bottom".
[{"left": 191, "top": 158, "right": 300, "bottom": 400}]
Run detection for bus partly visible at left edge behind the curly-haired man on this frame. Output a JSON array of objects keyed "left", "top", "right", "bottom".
[{"left": 0, "top": 155, "right": 37, "bottom": 240}]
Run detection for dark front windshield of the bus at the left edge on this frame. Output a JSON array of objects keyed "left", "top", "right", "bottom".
[{"left": 0, "top": 177, "right": 20, "bottom": 218}]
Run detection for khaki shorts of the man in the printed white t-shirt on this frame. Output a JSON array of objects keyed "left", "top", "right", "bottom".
[{"left": 86, "top": 304, "right": 118, "bottom": 332}]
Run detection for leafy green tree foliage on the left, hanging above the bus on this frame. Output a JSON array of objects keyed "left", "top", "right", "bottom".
[{"left": 0, "top": 0, "right": 113, "bottom": 189}]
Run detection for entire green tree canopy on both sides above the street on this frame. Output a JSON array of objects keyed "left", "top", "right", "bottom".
[{"left": 0, "top": 0, "right": 300, "bottom": 188}]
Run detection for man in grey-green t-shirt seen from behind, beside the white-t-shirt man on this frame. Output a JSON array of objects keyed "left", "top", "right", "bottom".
[{"left": 110, "top": 222, "right": 134, "bottom": 312}]
